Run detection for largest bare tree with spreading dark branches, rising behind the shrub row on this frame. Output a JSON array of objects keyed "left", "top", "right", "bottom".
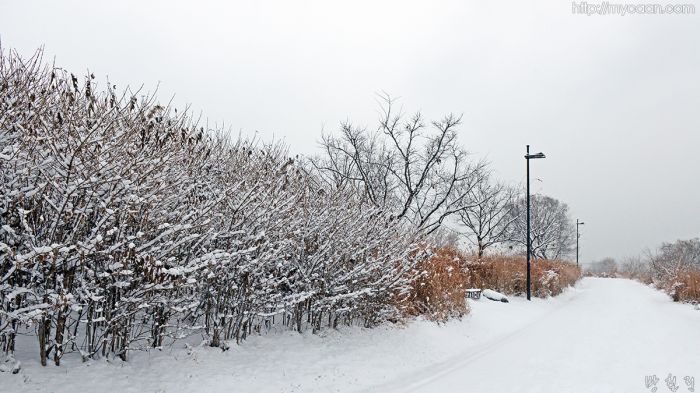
[{"left": 312, "top": 95, "right": 484, "bottom": 233}]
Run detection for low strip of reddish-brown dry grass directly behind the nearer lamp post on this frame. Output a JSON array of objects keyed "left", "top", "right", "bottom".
[{"left": 466, "top": 256, "right": 581, "bottom": 297}]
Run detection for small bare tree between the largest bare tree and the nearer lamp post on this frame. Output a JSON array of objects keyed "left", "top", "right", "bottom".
[{"left": 459, "top": 179, "right": 518, "bottom": 258}]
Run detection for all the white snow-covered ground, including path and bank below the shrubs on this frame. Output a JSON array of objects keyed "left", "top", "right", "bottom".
[{"left": 0, "top": 278, "right": 700, "bottom": 393}]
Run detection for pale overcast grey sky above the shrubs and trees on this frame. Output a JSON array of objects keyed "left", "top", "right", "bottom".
[{"left": 0, "top": 0, "right": 700, "bottom": 262}]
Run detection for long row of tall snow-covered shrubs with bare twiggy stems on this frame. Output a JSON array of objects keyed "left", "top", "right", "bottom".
[{"left": 0, "top": 51, "right": 421, "bottom": 365}]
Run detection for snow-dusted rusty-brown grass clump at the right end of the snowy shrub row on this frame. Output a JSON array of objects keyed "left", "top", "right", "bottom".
[{"left": 402, "top": 247, "right": 469, "bottom": 322}]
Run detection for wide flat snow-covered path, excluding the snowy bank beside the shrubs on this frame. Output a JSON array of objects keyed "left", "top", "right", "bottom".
[{"left": 377, "top": 278, "right": 700, "bottom": 393}]
